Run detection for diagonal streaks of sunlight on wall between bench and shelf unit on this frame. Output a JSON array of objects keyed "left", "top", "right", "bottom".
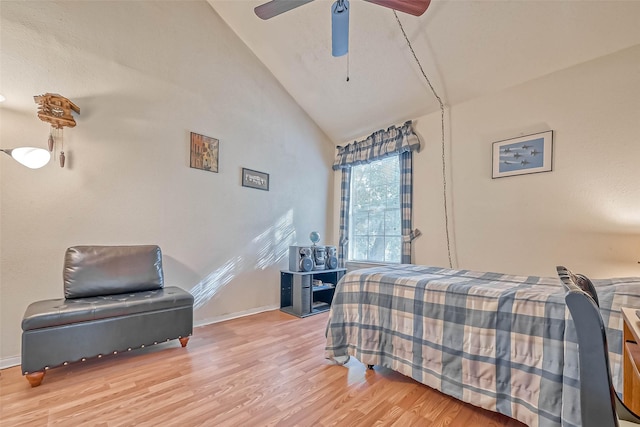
[{"left": 190, "top": 209, "right": 296, "bottom": 309}]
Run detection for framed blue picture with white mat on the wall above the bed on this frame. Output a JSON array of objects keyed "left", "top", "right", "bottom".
[{"left": 491, "top": 130, "right": 553, "bottom": 178}]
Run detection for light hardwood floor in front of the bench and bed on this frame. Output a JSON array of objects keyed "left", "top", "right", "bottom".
[{"left": 0, "top": 311, "right": 523, "bottom": 427}]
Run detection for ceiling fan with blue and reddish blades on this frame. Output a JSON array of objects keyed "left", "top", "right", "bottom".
[{"left": 253, "top": 0, "right": 431, "bottom": 56}]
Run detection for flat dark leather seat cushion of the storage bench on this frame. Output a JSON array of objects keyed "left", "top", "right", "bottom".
[{"left": 22, "top": 286, "right": 193, "bottom": 331}]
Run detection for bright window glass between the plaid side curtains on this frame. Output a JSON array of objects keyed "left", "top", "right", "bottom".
[{"left": 349, "top": 154, "right": 402, "bottom": 263}]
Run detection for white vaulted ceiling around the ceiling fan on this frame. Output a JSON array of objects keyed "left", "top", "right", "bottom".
[{"left": 208, "top": 0, "right": 640, "bottom": 143}]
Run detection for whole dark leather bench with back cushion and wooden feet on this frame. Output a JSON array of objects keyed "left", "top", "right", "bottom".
[{"left": 22, "top": 246, "right": 193, "bottom": 387}]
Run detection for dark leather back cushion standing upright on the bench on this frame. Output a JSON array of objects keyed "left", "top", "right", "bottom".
[{"left": 63, "top": 245, "right": 164, "bottom": 299}]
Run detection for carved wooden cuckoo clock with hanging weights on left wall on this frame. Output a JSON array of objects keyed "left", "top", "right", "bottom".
[{"left": 33, "top": 93, "right": 80, "bottom": 168}]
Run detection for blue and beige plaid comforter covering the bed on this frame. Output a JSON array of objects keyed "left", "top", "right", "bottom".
[{"left": 325, "top": 265, "right": 640, "bottom": 427}]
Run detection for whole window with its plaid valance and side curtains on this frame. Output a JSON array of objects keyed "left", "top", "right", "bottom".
[{"left": 333, "top": 120, "right": 420, "bottom": 266}]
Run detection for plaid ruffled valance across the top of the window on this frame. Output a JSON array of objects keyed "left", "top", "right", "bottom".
[{"left": 333, "top": 120, "right": 420, "bottom": 170}]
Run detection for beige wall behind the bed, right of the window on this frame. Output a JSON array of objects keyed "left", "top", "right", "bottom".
[{"left": 414, "top": 46, "right": 640, "bottom": 278}]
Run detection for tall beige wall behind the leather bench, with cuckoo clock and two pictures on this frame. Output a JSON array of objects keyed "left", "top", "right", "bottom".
[{"left": 0, "top": 1, "right": 333, "bottom": 366}]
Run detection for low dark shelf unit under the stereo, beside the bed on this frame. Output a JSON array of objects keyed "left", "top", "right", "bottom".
[{"left": 280, "top": 268, "right": 347, "bottom": 317}]
